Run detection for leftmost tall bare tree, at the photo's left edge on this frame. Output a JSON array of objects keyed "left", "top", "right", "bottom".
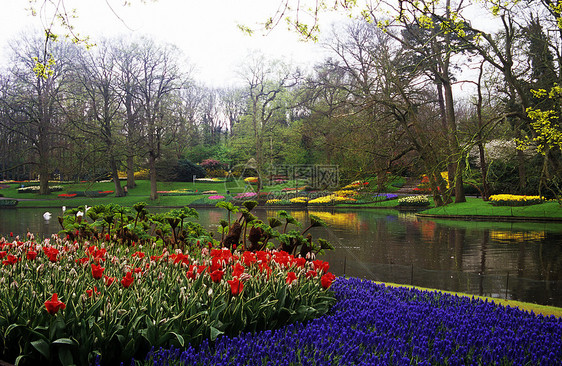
[{"left": 0, "top": 38, "right": 74, "bottom": 194}]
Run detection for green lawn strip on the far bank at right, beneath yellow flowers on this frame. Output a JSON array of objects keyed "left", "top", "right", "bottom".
[{"left": 420, "top": 197, "right": 562, "bottom": 219}]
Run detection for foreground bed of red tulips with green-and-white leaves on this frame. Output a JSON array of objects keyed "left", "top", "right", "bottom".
[{"left": 0, "top": 235, "right": 334, "bottom": 364}]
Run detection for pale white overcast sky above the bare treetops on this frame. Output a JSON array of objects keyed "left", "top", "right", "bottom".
[{"left": 0, "top": 0, "right": 334, "bottom": 87}]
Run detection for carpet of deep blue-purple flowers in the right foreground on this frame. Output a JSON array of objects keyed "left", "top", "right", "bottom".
[{"left": 135, "top": 278, "right": 562, "bottom": 366}]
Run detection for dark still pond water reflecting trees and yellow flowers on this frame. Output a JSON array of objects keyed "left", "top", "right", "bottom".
[{"left": 0, "top": 208, "right": 562, "bottom": 306}]
